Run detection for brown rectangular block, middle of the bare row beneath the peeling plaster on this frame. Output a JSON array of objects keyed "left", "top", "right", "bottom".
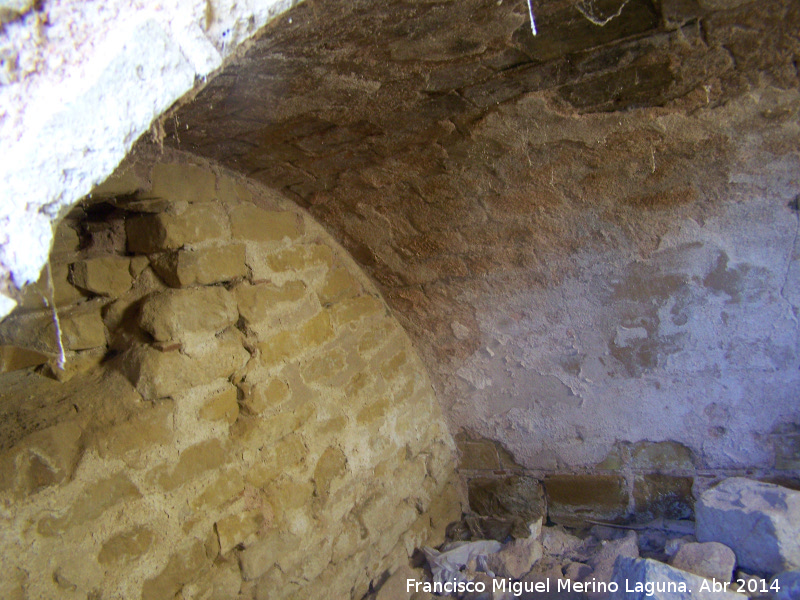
[{"left": 544, "top": 475, "right": 628, "bottom": 525}]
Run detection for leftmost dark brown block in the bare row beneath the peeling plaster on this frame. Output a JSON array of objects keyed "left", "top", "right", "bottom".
[{"left": 467, "top": 475, "right": 546, "bottom": 523}]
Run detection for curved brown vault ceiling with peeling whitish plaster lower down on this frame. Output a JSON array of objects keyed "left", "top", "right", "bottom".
[{"left": 165, "top": 0, "right": 800, "bottom": 483}]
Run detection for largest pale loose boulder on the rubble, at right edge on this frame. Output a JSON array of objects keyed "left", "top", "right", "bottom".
[{"left": 695, "top": 477, "right": 800, "bottom": 573}]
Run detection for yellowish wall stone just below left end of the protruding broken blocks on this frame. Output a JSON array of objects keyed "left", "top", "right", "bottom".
[{"left": 95, "top": 400, "right": 175, "bottom": 468}]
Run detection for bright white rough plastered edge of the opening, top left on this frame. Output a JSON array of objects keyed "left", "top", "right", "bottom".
[{"left": 0, "top": 0, "right": 300, "bottom": 318}]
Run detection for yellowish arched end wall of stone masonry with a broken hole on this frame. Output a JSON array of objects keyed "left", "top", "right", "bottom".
[{"left": 0, "top": 155, "right": 461, "bottom": 600}]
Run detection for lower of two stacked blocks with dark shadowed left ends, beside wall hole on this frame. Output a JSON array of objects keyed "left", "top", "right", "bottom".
[{"left": 151, "top": 244, "right": 247, "bottom": 287}]
